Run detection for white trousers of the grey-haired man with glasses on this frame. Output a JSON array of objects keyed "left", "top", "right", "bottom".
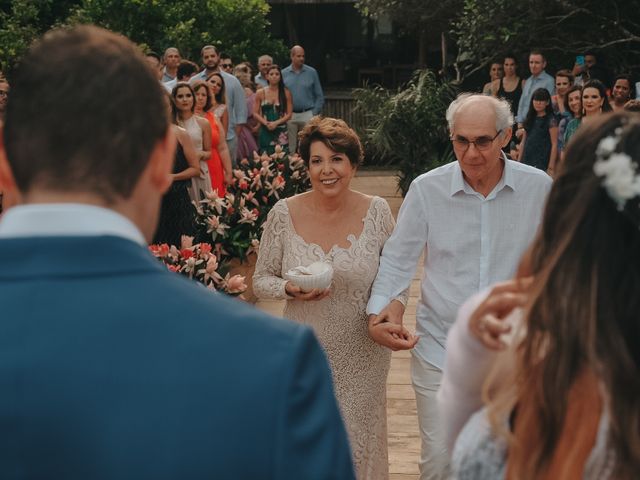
[{"left": 411, "top": 351, "right": 449, "bottom": 480}]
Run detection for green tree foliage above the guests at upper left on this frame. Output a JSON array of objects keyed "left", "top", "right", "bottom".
[{"left": 0, "top": 0, "right": 287, "bottom": 70}]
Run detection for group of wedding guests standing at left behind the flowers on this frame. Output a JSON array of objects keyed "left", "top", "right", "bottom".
[{"left": 139, "top": 45, "right": 324, "bottom": 245}]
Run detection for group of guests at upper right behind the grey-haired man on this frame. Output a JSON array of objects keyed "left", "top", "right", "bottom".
[{"left": 482, "top": 50, "right": 640, "bottom": 175}]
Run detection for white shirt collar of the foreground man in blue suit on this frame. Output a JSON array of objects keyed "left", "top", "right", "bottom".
[{"left": 0, "top": 203, "right": 147, "bottom": 245}]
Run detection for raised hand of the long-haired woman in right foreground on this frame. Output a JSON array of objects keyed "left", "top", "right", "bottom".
[{"left": 469, "top": 277, "right": 533, "bottom": 350}]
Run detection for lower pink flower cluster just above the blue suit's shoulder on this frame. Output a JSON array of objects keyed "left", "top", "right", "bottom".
[{"left": 149, "top": 235, "right": 247, "bottom": 296}]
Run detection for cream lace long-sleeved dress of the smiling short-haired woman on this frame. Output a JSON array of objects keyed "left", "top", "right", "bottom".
[{"left": 253, "top": 197, "right": 406, "bottom": 480}]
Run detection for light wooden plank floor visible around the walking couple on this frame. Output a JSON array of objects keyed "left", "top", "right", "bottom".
[{"left": 256, "top": 172, "right": 422, "bottom": 480}]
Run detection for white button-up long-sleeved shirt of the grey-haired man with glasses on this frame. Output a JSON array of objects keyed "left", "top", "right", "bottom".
[{"left": 367, "top": 159, "right": 551, "bottom": 369}]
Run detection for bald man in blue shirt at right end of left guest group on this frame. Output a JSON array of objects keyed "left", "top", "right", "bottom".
[{"left": 282, "top": 45, "right": 324, "bottom": 152}]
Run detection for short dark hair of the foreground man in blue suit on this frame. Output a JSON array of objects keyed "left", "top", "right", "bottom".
[{"left": 4, "top": 26, "right": 168, "bottom": 204}]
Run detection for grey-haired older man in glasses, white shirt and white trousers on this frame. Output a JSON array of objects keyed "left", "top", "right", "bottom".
[{"left": 367, "top": 94, "right": 551, "bottom": 480}]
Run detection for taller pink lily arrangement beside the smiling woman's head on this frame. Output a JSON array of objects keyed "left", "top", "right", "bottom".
[{"left": 197, "top": 146, "right": 310, "bottom": 263}]
